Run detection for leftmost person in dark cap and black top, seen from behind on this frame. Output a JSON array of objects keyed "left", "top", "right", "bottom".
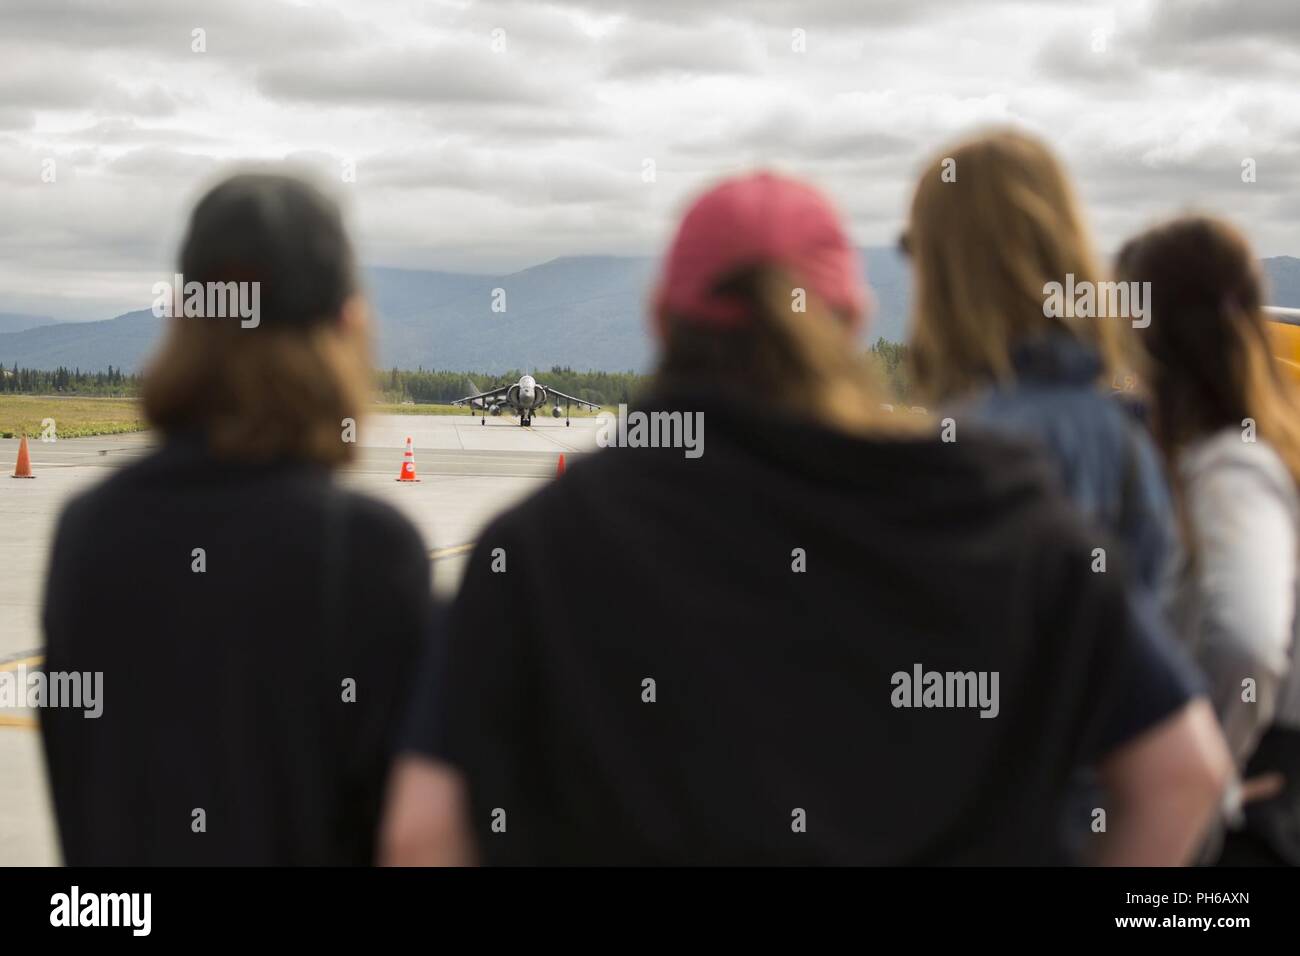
[{"left": 42, "top": 173, "right": 433, "bottom": 865}]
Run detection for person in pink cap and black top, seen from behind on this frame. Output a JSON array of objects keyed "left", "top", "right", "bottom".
[{"left": 381, "top": 173, "right": 1227, "bottom": 864}]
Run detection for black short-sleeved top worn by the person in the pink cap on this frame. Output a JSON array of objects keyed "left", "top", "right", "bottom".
[{"left": 407, "top": 395, "right": 1196, "bottom": 864}]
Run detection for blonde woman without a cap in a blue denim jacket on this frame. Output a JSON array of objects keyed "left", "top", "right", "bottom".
[{"left": 902, "top": 130, "right": 1174, "bottom": 594}]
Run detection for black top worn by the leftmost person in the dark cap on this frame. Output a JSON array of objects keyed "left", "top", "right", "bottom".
[{"left": 42, "top": 436, "right": 433, "bottom": 865}]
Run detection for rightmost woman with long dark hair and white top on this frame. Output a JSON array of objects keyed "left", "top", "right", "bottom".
[{"left": 1118, "top": 216, "right": 1300, "bottom": 865}]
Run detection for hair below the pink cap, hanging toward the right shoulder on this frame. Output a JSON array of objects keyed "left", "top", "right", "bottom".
[{"left": 655, "top": 265, "right": 924, "bottom": 436}]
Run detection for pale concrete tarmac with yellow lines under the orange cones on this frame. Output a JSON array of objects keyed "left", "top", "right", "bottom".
[{"left": 0, "top": 414, "right": 598, "bottom": 865}]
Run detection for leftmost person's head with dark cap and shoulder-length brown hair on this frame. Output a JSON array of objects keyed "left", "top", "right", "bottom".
[{"left": 143, "top": 174, "right": 371, "bottom": 464}]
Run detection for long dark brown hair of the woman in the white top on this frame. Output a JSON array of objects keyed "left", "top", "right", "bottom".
[{"left": 1117, "top": 216, "right": 1300, "bottom": 486}]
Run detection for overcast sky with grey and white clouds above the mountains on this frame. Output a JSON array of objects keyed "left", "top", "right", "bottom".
[{"left": 0, "top": 0, "right": 1300, "bottom": 319}]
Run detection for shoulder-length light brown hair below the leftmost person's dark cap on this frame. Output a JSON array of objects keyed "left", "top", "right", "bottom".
[{"left": 143, "top": 317, "right": 371, "bottom": 464}]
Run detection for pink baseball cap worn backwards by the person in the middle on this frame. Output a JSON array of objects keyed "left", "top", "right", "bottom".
[{"left": 654, "top": 172, "right": 868, "bottom": 333}]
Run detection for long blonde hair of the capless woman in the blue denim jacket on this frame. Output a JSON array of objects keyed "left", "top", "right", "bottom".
[{"left": 905, "top": 130, "right": 1132, "bottom": 399}]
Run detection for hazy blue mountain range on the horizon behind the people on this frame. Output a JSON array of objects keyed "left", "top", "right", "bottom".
[{"left": 0, "top": 248, "right": 1300, "bottom": 372}]
